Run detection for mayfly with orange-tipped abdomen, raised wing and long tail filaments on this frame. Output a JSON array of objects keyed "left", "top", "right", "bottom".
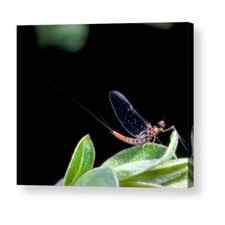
[{"left": 78, "top": 91, "right": 185, "bottom": 145}]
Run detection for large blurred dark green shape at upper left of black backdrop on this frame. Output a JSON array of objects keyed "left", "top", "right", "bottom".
[{"left": 36, "top": 24, "right": 89, "bottom": 52}]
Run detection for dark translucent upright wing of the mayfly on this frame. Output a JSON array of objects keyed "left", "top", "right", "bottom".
[{"left": 109, "top": 91, "right": 151, "bottom": 137}]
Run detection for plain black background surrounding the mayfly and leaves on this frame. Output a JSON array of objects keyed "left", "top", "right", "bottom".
[{"left": 17, "top": 23, "right": 193, "bottom": 185}]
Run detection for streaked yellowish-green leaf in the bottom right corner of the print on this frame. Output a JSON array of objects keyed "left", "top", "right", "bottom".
[{"left": 120, "top": 158, "right": 192, "bottom": 188}]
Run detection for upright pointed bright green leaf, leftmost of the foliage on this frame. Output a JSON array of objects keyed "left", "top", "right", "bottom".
[{"left": 64, "top": 135, "right": 95, "bottom": 186}]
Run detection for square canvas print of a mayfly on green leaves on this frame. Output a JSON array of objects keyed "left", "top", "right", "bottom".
[{"left": 17, "top": 23, "right": 194, "bottom": 189}]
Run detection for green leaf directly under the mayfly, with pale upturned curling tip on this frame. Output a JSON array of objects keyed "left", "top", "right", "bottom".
[{"left": 102, "top": 131, "right": 178, "bottom": 181}]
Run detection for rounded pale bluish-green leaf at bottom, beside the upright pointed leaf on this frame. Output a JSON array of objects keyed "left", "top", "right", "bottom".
[{"left": 75, "top": 167, "right": 119, "bottom": 187}]
